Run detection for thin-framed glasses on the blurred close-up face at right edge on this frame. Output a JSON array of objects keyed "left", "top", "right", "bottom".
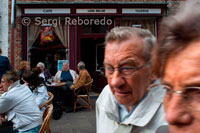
[{"left": 148, "top": 84, "right": 200, "bottom": 111}]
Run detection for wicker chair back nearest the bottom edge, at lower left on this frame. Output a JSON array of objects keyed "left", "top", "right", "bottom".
[{"left": 39, "top": 104, "right": 53, "bottom": 133}]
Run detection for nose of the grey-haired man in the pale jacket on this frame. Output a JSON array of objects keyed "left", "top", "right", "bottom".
[{"left": 111, "top": 71, "right": 125, "bottom": 88}]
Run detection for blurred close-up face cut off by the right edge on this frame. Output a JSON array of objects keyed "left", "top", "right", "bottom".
[{"left": 163, "top": 41, "right": 200, "bottom": 133}]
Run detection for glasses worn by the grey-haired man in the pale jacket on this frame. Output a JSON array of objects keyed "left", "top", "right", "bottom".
[{"left": 100, "top": 62, "right": 149, "bottom": 78}]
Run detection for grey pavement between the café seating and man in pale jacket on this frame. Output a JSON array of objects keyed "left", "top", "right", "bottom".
[{"left": 50, "top": 93, "right": 97, "bottom": 133}]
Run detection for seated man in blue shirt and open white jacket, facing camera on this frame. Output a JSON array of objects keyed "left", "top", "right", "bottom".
[{"left": 55, "top": 62, "right": 78, "bottom": 112}]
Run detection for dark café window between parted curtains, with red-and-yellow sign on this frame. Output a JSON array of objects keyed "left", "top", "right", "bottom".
[{"left": 29, "top": 27, "right": 66, "bottom": 75}]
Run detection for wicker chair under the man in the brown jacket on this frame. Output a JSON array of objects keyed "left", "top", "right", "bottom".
[{"left": 74, "top": 79, "right": 93, "bottom": 112}]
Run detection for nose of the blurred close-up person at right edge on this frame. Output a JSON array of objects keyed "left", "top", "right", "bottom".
[{"left": 164, "top": 94, "right": 193, "bottom": 126}]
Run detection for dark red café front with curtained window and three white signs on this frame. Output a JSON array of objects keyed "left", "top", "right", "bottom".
[{"left": 10, "top": 0, "right": 184, "bottom": 91}]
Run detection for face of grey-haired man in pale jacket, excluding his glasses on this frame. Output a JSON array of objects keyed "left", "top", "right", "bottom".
[{"left": 104, "top": 36, "right": 150, "bottom": 111}]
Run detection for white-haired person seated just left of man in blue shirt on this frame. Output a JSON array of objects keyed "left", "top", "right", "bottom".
[{"left": 36, "top": 62, "right": 51, "bottom": 82}]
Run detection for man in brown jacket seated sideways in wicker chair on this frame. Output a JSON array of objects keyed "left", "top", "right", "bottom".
[{"left": 70, "top": 61, "right": 92, "bottom": 90}]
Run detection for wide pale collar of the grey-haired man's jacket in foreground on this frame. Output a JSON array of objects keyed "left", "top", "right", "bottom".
[{"left": 106, "top": 81, "right": 165, "bottom": 127}]
